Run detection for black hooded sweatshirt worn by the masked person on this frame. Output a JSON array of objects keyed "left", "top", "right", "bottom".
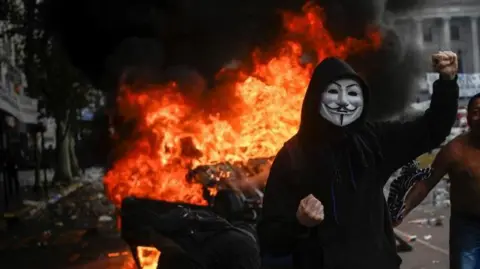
[{"left": 258, "top": 58, "right": 458, "bottom": 269}]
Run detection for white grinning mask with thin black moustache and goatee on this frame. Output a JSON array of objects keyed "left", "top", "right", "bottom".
[{"left": 319, "top": 79, "right": 363, "bottom": 126}]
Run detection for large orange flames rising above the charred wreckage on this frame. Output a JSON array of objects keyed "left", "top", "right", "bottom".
[{"left": 105, "top": 1, "right": 381, "bottom": 266}]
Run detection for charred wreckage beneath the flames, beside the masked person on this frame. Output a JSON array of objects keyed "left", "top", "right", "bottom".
[{"left": 121, "top": 159, "right": 271, "bottom": 268}]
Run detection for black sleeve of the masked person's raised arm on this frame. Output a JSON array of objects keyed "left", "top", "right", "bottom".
[{"left": 374, "top": 78, "right": 459, "bottom": 179}]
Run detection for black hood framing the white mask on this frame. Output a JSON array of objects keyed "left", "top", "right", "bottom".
[{"left": 299, "top": 57, "right": 370, "bottom": 144}]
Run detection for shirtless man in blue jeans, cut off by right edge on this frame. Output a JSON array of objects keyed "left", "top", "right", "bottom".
[{"left": 403, "top": 93, "right": 480, "bottom": 269}]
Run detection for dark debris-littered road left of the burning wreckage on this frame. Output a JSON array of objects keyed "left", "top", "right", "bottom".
[{"left": 0, "top": 182, "right": 126, "bottom": 269}]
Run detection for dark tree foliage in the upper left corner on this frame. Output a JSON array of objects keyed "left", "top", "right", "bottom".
[{"left": 0, "top": 0, "right": 90, "bottom": 114}]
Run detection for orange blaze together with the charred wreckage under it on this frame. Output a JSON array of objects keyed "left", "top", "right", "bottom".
[{"left": 104, "top": 4, "right": 380, "bottom": 268}]
